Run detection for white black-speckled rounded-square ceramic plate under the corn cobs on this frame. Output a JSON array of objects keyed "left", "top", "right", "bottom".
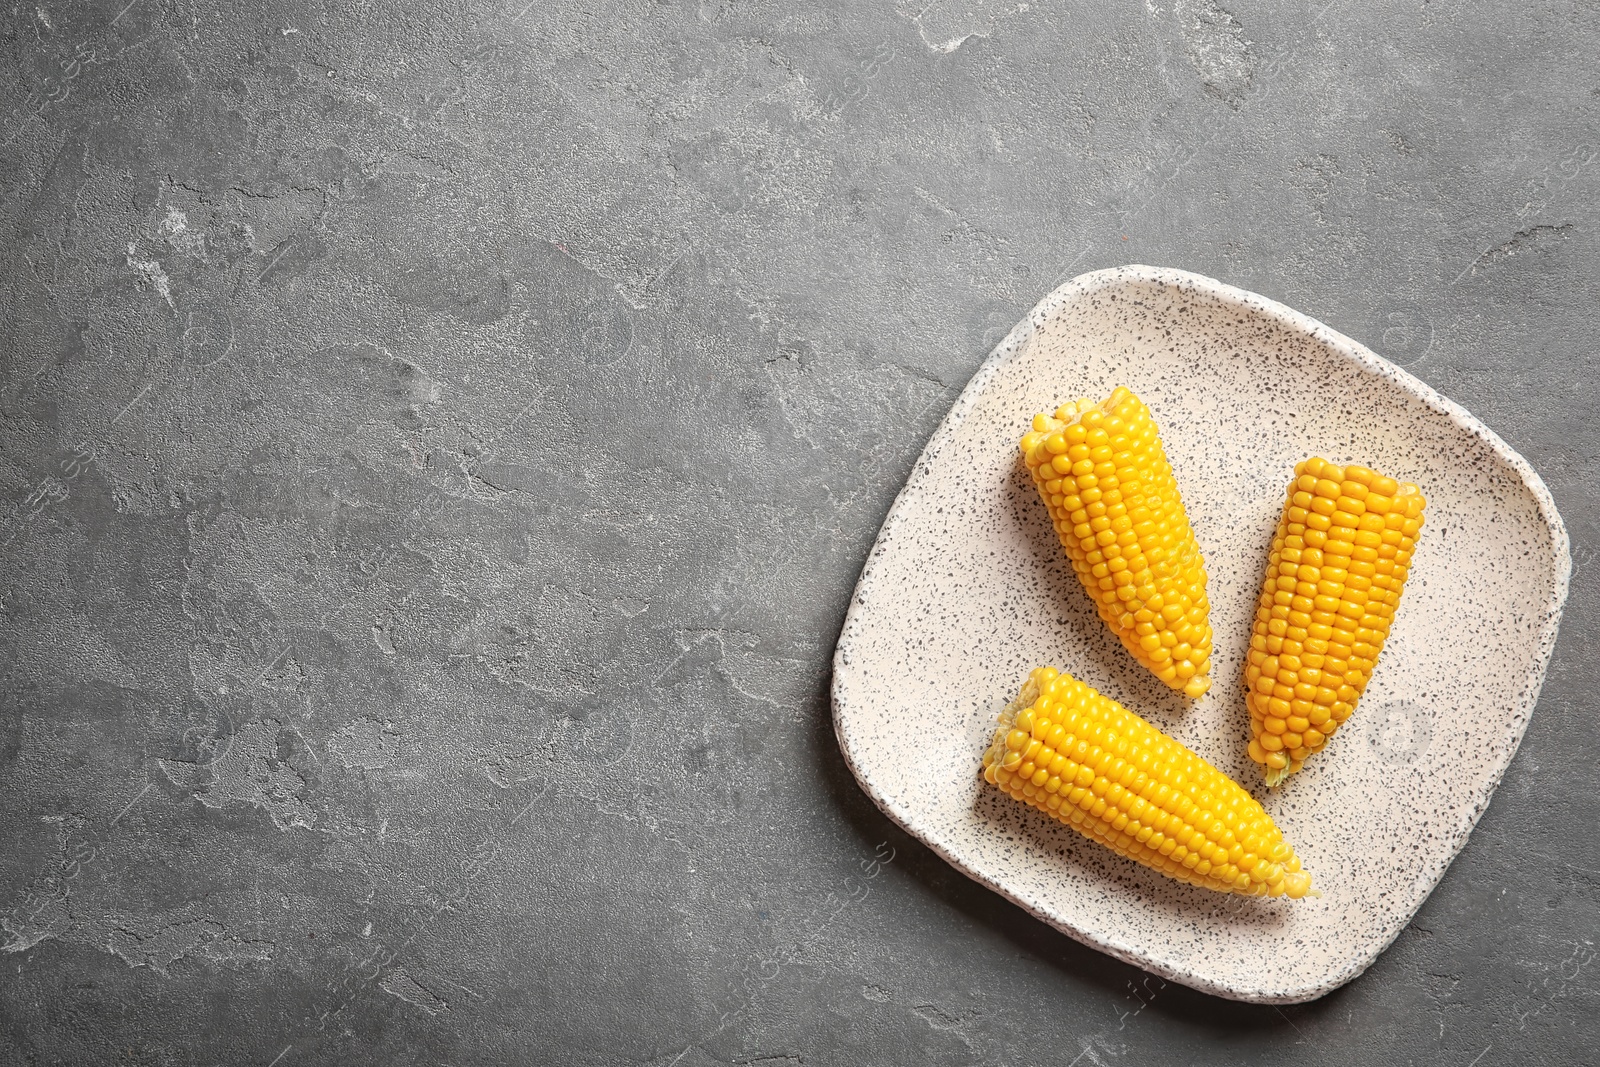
[{"left": 834, "top": 267, "right": 1571, "bottom": 1003}]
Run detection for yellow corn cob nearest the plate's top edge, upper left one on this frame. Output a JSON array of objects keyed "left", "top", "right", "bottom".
[{"left": 1022, "top": 386, "right": 1211, "bottom": 696}]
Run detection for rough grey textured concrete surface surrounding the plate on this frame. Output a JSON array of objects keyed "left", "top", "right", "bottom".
[{"left": 0, "top": 0, "right": 1600, "bottom": 1067}]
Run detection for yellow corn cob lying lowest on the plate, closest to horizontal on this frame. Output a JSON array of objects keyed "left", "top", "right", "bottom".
[{"left": 984, "top": 667, "right": 1314, "bottom": 899}]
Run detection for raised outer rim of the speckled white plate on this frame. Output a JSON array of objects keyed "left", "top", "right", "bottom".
[{"left": 829, "top": 264, "right": 1571, "bottom": 1005}]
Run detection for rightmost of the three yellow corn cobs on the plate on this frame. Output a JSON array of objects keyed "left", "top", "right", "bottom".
[{"left": 1245, "top": 459, "right": 1424, "bottom": 785}]
